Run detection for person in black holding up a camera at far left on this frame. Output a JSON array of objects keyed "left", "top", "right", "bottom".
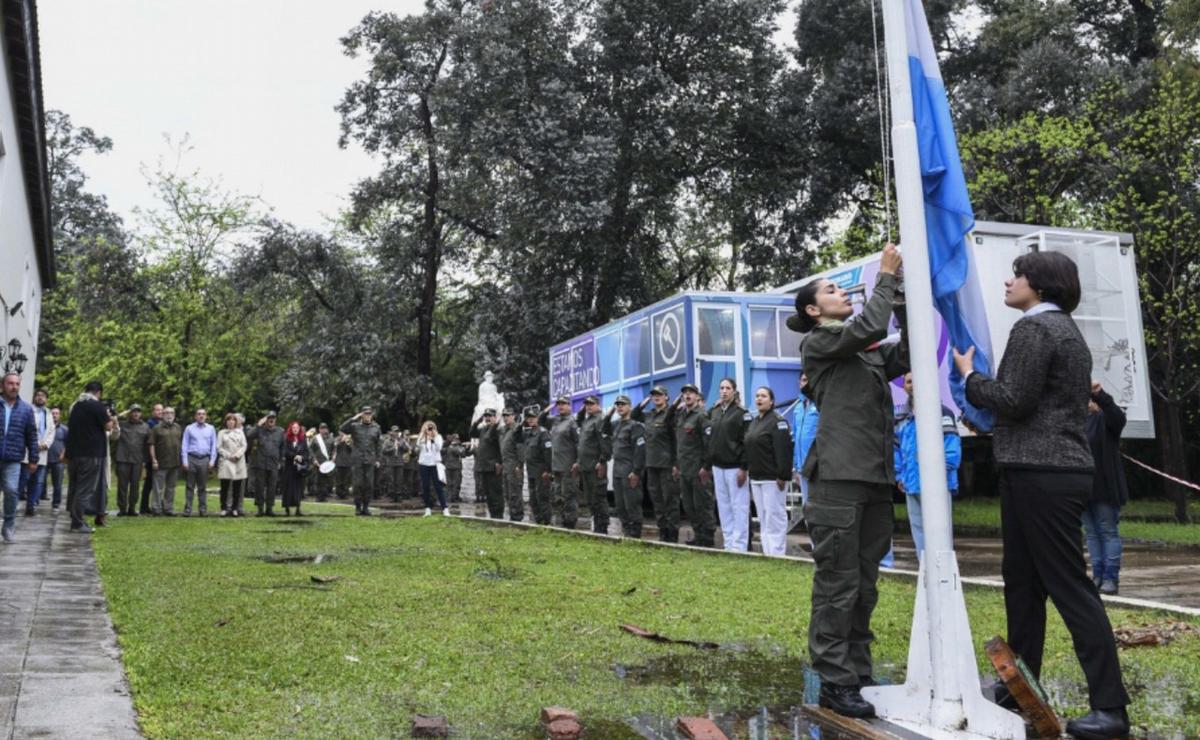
[{"left": 66, "top": 380, "right": 116, "bottom": 534}]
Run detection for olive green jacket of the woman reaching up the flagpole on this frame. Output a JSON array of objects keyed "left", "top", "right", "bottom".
[{"left": 800, "top": 273, "right": 908, "bottom": 485}]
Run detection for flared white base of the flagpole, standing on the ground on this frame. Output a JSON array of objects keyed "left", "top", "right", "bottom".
[{"left": 863, "top": 551, "right": 1025, "bottom": 740}]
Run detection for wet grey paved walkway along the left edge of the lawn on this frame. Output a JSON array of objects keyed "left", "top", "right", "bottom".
[{"left": 0, "top": 506, "right": 140, "bottom": 739}]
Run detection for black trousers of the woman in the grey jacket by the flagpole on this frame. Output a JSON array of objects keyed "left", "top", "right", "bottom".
[{"left": 1000, "top": 468, "right": 1129, "bottom": 709}]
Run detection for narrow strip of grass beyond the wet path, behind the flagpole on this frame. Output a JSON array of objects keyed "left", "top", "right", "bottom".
[{"left": 895, "top": 498, "right": 1200, "bottom": 546}]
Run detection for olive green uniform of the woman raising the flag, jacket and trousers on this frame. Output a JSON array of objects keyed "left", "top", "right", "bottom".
[{"left": 800, "top": 273, "right": 908, "bottom": 686}]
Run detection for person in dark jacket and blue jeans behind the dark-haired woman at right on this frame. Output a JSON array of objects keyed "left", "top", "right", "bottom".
[{"left": 1084, "top": 383, "right": 1129, "bottom": 595}]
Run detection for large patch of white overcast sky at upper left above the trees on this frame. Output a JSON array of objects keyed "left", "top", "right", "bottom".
[{"left": 37, "top": 0, "right": 424, "bottom": 228}]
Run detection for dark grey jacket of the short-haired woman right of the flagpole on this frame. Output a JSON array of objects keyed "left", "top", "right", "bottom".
[{"left": 964, "top": 311, "right": 1094, "bottom": 473}]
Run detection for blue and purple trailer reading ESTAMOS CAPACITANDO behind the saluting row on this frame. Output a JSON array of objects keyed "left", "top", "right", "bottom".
[{"left": 550, "top": 291, "right": 800, "bottom": 409}]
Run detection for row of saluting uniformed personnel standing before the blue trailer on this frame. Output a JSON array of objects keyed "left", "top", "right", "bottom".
[{"left": 472, "top": 380, "right": 792, "bottom": 549}]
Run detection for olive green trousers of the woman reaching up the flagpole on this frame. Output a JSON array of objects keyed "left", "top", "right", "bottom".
[{"left": 804, "top": 480, "right": 893, "bottom": 686}]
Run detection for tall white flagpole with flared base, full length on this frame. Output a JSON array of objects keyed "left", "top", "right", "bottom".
[{"left": 863, "top": 0, "right": 1025, "bottom": 738}]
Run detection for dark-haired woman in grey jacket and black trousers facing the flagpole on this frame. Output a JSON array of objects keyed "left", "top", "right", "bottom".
[{"left": 954, "top": 252, "right": 1129, "bottom": 738}]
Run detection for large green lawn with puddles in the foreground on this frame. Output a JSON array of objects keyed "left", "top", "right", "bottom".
[{"left": 94, "top": 506, "right": 1200, "bottom": 738}]
